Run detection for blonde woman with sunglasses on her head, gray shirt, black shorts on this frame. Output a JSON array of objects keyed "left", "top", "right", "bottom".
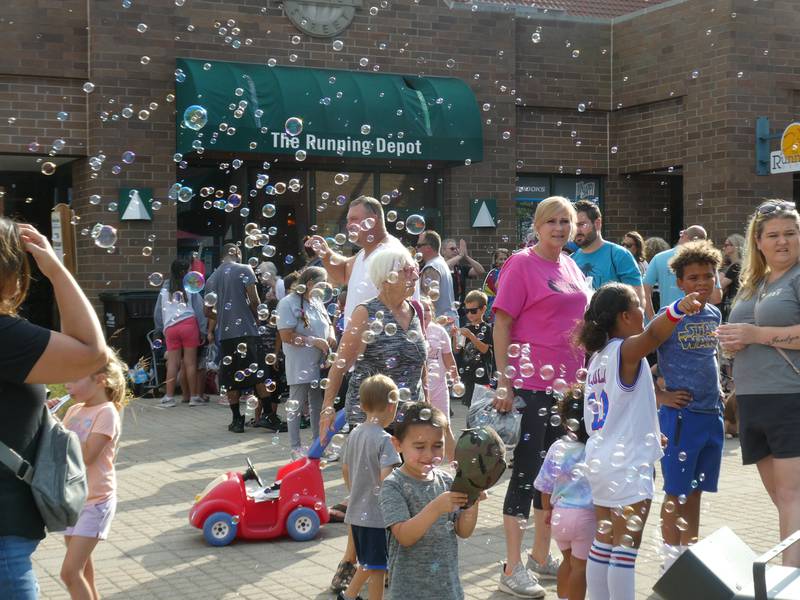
[{"left": 719, "top": 200, "right": 800, "bottom": 567}]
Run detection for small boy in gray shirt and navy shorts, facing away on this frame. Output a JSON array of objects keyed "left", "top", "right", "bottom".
[{"left": 337, "top": 375, "right": 400, "bottom": 600}]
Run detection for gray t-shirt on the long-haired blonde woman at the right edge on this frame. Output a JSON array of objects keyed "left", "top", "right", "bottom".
[{"left": 728, "top": 264, "right": 800, "bottom": 396}]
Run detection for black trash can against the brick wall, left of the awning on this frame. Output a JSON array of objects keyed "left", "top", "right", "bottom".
[{"left": 100, "top": 290, "right": 158, "bottom": 367}]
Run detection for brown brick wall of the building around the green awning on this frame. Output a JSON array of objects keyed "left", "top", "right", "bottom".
[{"left": 0, "top": 0, "right": 800, "bottom": 310}]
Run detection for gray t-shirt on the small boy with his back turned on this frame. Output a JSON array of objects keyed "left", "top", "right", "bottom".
[{"left": 342, "top": 423, "right": 401, "bottom": 529}]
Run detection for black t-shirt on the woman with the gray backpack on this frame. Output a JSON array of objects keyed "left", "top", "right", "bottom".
[{"left": 0, "top": 315, "right": 50, "bottom": 540}]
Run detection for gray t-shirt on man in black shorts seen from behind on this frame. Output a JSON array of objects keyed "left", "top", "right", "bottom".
[{"left": 205, "top": 262, "right": 258, "bottom": 340}]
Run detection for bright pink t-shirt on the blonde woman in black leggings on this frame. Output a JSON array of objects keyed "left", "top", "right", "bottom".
[{"left": 492, "top": 248, "right": 589, "bottom": 390}]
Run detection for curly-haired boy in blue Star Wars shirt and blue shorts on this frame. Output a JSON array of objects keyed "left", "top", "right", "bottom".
[{"left": 656, "top": 240, "right": 725, "bottom": 571}]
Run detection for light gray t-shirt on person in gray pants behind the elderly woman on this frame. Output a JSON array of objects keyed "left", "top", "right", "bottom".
[{"left": 277, "top": 292, "right": 332, "bottom": 385}]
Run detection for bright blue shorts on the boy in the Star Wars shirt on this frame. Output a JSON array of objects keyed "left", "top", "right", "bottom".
[{"left": 658, "top": 406, "right": 725, "bottom": 496}]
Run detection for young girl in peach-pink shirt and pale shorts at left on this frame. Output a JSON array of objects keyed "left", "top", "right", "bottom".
[{"left": 61, "top": 351, "right": 127, "bottom": 600}]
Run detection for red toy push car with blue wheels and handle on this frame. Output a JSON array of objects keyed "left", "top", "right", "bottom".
[{"left": 189, "top": 410, "right": 345, "bottom": 546}]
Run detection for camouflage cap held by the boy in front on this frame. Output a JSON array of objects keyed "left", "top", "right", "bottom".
[{"left": 450, "top": 425, "right": 506, "bottom": 506}]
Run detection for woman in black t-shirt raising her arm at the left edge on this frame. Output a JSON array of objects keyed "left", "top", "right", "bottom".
[{"left": 0, "top": 217, "right": 107, "bottom": 600}]
